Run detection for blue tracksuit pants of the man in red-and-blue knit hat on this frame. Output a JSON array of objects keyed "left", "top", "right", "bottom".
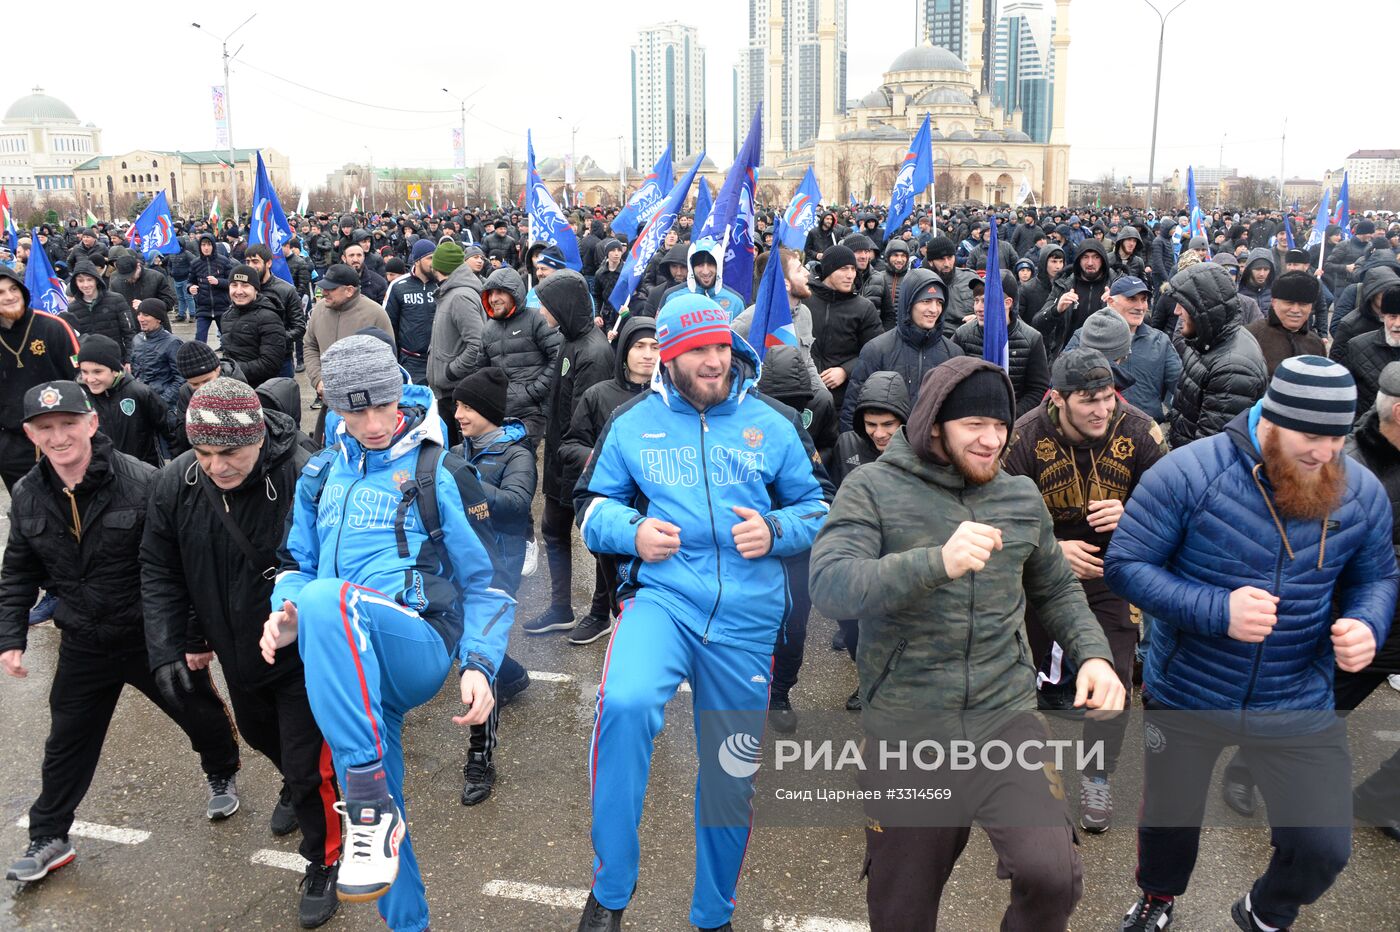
[{"left": 588, "top": 591, "right": 773, "bottom": 928}]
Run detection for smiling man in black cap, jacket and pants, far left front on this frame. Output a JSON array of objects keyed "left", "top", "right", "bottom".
[{"left": 0, "top": 382, "right": 238, "bottom": 882}]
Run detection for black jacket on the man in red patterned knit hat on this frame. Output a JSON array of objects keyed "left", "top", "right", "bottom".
[{"left": 140, "top": 410, "right": 309, "bottom": 689}]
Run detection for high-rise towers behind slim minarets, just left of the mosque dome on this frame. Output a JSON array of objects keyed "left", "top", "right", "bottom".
[{"left": 734, "top": 0, "right": 847, "bottom": 151}]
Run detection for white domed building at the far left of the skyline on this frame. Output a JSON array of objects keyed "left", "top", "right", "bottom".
[{"left": 0, "top": 87, "right": 102, "bottom": 197}]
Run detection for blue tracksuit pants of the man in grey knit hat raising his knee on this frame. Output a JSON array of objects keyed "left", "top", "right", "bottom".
[{"left": 297, "top": 578, "right": 452, "bottom": 932}]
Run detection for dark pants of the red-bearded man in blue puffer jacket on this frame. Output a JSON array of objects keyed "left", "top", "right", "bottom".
[{"left": 1137, "top": 701, "right": 1351, "bottom": 928}]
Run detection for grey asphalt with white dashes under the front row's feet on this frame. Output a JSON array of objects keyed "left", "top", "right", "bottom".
[{"left": 0, "top": 325, "right": 1400, "bottom": 932}]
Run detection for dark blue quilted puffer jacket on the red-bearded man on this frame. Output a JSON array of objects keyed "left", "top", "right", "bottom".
[{"left": 1103, "top": 403, "right": 1397, "bottom": 711}]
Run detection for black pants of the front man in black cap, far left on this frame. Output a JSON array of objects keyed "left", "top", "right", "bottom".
[{"left": 29, "top": 634, "right": 238, "bottom": 838}]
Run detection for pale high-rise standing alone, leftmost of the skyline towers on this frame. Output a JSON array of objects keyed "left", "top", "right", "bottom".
[{"left": 631, "top": 22, "right": 706, "bottom": 171}]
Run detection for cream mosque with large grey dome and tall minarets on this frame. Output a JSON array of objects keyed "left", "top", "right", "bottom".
[{"left": 759, "top": 0, "right": 1070, "bottom": 204}]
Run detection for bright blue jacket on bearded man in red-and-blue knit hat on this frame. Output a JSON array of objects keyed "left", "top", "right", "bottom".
[{"left": 574, "top": 306, "right": 833, "bottom": 654}]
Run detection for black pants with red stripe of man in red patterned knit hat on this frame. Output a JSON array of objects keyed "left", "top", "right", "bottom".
[{"left": 224, "top": 663, "right": 340, "bottom": 865}]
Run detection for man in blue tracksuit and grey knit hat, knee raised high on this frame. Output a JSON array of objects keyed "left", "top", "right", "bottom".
[{"left": 262, "top": 334, "right": 515, "bottom": 932}]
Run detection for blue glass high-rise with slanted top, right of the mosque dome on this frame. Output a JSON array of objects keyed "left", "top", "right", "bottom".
[{"left": 990, "top": 0, "right": 1054, "bottom": 143}]
